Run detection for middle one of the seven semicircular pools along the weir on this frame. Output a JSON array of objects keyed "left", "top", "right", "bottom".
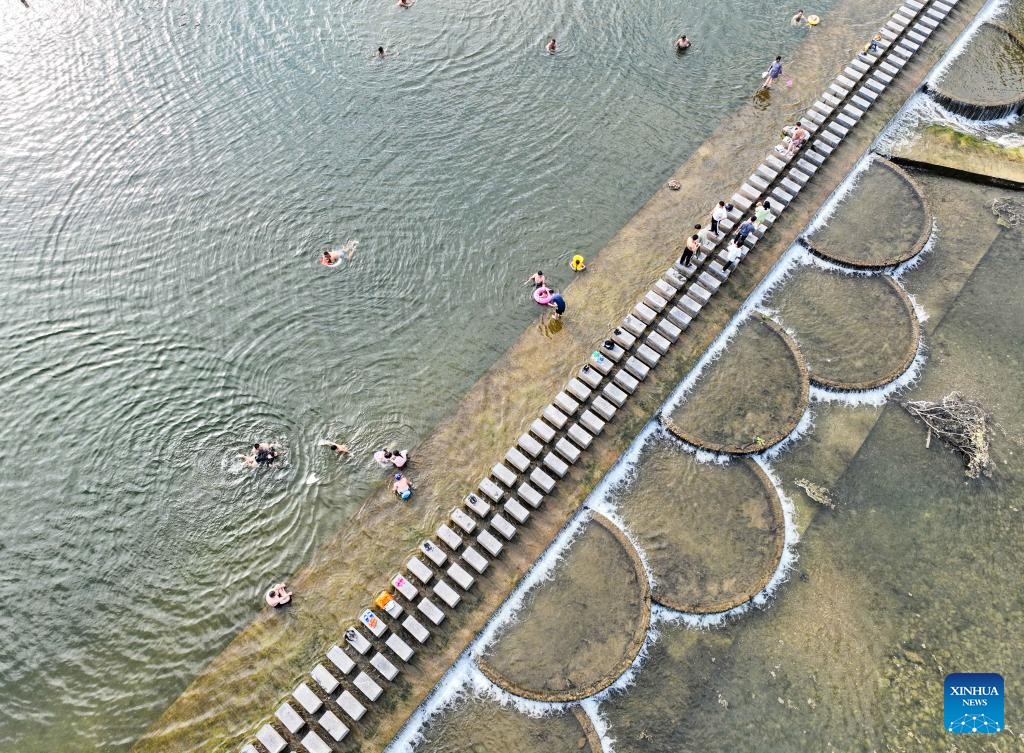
[{"left": 663, "top": 317, "right": 810, "bottom": 455}]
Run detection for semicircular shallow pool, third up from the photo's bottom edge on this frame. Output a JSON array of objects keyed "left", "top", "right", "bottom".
[{"left": 614, "top": 434, "right": 785, "bottom": 614}]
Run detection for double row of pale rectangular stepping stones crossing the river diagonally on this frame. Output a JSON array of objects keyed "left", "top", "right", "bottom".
[{"left": 242, "top": 0, "right": 958, "bottom": 753}]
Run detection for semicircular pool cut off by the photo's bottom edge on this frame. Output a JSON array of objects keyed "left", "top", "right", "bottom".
[{"left": 416, "top": 697, "right": 601, "bottom": 753}]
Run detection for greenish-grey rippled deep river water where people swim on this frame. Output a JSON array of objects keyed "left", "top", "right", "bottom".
[{"left": 0, "top": 0, "right": 827, "bottom": 753}]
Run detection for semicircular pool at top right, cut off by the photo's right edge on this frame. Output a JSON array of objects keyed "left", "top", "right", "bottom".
[{"left": 932, "top": 23, "right": 1024, "bottom": 119}]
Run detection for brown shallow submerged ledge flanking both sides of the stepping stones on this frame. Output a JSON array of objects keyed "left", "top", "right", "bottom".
[{"left": 135, "top": 0, "right": 981, "bottom": 751}]
